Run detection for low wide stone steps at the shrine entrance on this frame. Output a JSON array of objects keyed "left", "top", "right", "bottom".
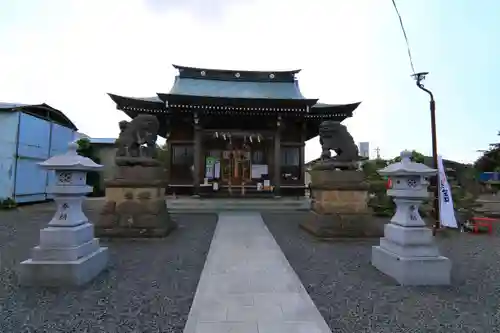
[{"left": 167, "top": 197, "right": 311, "bottom": 214}]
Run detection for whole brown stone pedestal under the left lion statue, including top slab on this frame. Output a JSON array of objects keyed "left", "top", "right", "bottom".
[{"left": 95, "top": 165, "right": 177, "bottom": 238}]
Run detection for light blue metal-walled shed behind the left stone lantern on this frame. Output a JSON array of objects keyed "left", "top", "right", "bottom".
[{"left": 0, "top": 103, "right": 77, "bottom": 203}]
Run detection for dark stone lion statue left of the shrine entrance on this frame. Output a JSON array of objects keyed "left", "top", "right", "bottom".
[{"left": 115, "top": 114, "right": 160, "bottom": 158}]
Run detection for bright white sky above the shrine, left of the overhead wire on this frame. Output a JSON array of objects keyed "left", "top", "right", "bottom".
[{"left": 0, "top": 0, "right": 464, "bottom": 161}]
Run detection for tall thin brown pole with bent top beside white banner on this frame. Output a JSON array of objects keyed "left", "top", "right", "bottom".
[{"left": 412, "top": 72, "right": 441, "bottom": 236}]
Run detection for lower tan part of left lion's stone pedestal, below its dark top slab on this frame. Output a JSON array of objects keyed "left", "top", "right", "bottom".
[{"left": 95, "top": 184, "right": 177, "bottom": 238}]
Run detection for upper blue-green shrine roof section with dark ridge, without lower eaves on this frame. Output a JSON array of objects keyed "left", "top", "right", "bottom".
[{"left": 169, "top": 65, "right": 305, "bottom": 100}]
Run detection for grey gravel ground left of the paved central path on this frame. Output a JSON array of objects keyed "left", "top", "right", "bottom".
[{"left": 0, "top": 204, "right": 216, "bottom": 333}]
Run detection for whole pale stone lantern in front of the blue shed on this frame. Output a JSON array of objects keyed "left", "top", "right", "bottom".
[{"left": 19, "top": 143, "right": 108, "bottom": 286}]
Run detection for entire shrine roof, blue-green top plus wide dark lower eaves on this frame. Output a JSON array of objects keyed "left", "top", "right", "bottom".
[{"left": 109, "top": 65, "right": 359, "bottom": 119}]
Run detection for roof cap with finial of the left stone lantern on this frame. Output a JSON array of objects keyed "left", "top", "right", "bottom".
[{"left": 38, "top": 142, "right": 103, "bottom": 171}]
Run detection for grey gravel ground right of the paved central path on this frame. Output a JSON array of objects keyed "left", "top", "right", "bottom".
[{"left": 263, "top": 213, "right": 500, "bottom": 333}]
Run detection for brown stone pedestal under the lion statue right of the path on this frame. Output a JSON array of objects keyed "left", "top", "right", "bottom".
[{"left": 300, "top": 166, "right": 384, "bottom": 239}]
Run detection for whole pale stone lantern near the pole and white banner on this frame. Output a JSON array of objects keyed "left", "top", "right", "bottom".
[{"left": 372, "top": 151, "right": 451, "bottom": 285}]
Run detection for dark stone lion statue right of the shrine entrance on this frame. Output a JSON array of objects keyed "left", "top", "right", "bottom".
[{"left": 319, "top": 120, "right": 359, "bottom": 162}]
